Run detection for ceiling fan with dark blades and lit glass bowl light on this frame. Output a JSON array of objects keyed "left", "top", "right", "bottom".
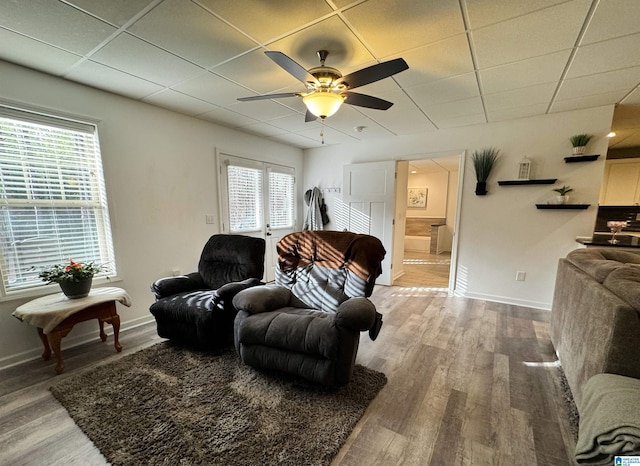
[{"left": 238, "top": 50, "right": 409, "bottom": 121}]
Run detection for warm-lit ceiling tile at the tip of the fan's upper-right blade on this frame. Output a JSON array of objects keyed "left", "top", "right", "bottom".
[{"left": 396, "top": 34, "right": 473, "bottom": 87}]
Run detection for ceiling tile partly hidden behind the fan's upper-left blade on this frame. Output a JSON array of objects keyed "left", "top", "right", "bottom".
[{"left": 212, "top": 49, "right": 306, "bottom": 97}]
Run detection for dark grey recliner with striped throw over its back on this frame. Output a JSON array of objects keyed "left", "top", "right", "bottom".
[{"left": 233, "top": 231, "right": 385, "bottom": 385}]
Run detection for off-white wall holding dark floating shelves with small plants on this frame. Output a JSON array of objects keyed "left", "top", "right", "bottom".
[{"left": 304, "top": 106, "right": 613, "bottom": 309}]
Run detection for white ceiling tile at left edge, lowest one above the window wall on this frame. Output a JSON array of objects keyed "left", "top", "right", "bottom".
[{"left": 0, "top": 28, "right": 81, "bottom": 75}]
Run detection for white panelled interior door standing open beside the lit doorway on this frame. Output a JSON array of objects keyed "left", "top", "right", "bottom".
[{"left": 342, "top": 160, "right": 396, "bottom": 286}]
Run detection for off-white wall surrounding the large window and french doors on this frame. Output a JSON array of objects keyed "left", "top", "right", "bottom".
[{"left": 0, "top": 61, "right": 303, "bottom": 371}]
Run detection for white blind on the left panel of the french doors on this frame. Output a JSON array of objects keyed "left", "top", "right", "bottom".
[{"left": 227, "top": 164, "right": 262, "bottom": 233}]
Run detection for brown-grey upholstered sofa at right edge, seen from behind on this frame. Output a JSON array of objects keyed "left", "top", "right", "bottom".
[{"left": 550, "top": 248, "right": 640, "bottom": 414}]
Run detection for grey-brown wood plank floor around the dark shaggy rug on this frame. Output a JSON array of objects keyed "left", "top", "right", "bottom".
[{"left": 0, "top": 286, "right": 576, "bottom": 466}]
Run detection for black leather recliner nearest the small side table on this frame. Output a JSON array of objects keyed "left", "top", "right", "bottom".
[{"left": 149, "top": 234, "right": 265, "bottom": 349}]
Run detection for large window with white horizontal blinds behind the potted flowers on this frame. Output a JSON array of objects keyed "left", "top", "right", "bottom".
[{"left": 0, "top": 105, "right": 116, "bottom": 296}]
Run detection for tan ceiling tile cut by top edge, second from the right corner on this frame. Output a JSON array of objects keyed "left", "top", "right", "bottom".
[{"left": 465, "top": 0, "right": 567, "bottom": 29}]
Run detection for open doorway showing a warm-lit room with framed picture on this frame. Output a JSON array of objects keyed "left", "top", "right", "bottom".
[{"left": 393, "top": 155, "right": 460, "bottom": 289}]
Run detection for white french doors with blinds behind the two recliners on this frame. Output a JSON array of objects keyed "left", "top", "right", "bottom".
[{"left": 218, "top": 153, "right": 296, "bottom": 281}]
